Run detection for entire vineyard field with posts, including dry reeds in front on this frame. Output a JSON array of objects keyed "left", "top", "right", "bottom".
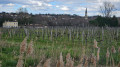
[{"left": 0, "top": 27, "right": 120, "bottom": 67}]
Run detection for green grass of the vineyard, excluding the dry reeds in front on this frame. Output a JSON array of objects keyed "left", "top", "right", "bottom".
[{"left": 0, "top": 28, "right": 120, "bottom": 67}]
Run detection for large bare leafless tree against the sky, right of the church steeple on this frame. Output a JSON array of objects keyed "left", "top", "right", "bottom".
[{"left": 100, "top": 2, "right": 115, "bottom": 17}]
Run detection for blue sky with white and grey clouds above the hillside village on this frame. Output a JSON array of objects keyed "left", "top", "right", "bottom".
[{"left": 0, "top": 0, "right": 120, "bottom": 17}]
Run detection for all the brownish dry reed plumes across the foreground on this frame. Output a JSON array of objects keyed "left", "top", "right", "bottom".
[{"left": 16, "top": 38, "right": 120, "bottom": 67}]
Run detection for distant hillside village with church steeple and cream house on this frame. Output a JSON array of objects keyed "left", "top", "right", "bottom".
[{"left": 0, "top": 8, "right": 101, "bottom": 28}]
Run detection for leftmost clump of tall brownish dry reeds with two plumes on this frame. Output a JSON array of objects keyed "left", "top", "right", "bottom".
[{"left": 16, "top": 37, "right": 34, "bottom": 67}]
